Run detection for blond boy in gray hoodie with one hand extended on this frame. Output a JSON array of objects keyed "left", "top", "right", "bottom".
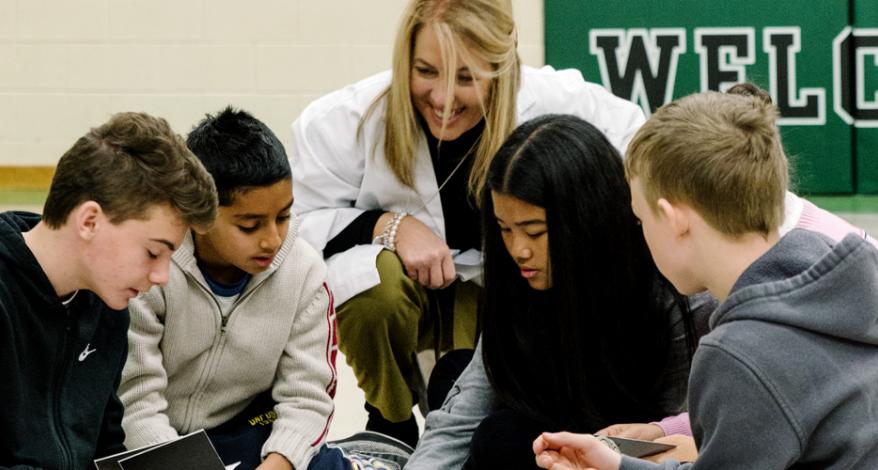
[{"left": 534, "top": 92, "right": 878, "bottom": 470}]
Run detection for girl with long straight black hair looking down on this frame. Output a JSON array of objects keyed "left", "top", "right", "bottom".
[{"left": 406, "top": 115, "right": 693, "bottom": 469}]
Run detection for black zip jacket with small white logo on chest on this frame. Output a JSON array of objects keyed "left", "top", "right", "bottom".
[{"left": 0, "top": 212, "right": 128, "bottom": 469}]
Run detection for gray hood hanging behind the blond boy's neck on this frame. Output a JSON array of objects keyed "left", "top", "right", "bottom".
[{"left": 710, "top": 230, "right": 878, "bottom": 345}]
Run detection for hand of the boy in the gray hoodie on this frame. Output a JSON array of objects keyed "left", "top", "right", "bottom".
[{"left": 533, "top": 432, "right": 622, "bottom": 470}]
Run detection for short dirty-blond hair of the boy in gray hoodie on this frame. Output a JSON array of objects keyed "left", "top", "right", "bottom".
[{"left": 625, "top": 91, "right": 789, "bottom": 236}]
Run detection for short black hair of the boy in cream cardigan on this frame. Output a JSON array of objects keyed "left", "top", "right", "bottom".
[{"left": 186, "top": 106, "right": 292, "bottom": 206}]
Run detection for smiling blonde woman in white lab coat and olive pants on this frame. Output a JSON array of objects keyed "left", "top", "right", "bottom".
[{"left": 291, "top": 0, "right": 644, "bottom": 445}]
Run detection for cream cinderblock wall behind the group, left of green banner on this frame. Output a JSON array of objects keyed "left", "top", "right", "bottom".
[{"left": 0, "top": 0, "right": 544, "bottom": 167}]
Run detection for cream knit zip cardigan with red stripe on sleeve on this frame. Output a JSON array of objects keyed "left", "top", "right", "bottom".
[{"left": 119, "top": 220, "right": 336, "bottom": 469}]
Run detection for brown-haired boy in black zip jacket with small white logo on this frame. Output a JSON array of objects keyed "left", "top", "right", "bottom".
[{"left": 0, "top": 113, "right": 217, "bottom": 469}]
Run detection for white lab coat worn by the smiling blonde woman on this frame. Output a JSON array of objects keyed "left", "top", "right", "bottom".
[{"left": 290, "top": 67, "right": 644, "bottom": 305}]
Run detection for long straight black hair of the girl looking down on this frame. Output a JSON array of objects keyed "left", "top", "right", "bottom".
[{"left": 482, "top": 115, "right": 692, "bottom": 432}]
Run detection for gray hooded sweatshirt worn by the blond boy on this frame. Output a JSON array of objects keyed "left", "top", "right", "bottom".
[{"left": 621, "top": 230, "right": 878, "bottom": 470}]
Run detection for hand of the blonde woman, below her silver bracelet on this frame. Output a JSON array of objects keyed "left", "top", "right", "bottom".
[{"left": 396, "top": 216, "right": 457, "bottom": 289}]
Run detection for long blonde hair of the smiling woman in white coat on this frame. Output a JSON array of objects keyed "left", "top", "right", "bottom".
[{"left": 358, "top": 0, "right": 521, "bottom": 199}]
